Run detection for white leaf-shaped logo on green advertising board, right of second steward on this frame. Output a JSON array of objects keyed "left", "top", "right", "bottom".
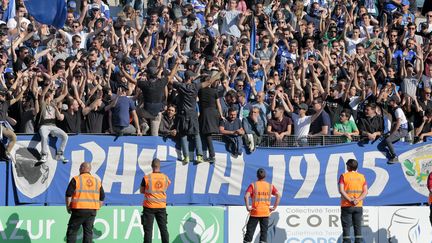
[{"left": 179, "top": 211, "right": 220, "bottom": 243}]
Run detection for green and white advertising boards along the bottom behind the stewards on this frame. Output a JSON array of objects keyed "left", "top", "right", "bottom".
[{"left": 0, "top": 206, "right": 432, "bottom": 243}]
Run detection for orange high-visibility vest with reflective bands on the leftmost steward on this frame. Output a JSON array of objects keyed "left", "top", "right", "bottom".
[{"left": 70, "top": 173, "right": 102, "bottom": 210}]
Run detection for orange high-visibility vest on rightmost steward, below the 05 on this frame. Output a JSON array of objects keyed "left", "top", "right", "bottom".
[{"left": 341, "top": 171, "right": 366, "bottom": 207}]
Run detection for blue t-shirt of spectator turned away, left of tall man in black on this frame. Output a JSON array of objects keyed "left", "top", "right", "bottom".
[{"left": 111, "top": 96, "right": 135, "bottom": 127}]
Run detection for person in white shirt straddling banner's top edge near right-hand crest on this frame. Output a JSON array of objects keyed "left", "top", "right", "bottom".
[{"left": 378, "top": 95, "right": 408, "bottom": 164}]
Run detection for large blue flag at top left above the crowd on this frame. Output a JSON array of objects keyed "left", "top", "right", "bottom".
[{"left": 24, "top": 0, "right": 66, "bottom": 28}]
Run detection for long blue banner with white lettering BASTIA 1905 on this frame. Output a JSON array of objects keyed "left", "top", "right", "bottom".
[{"left": 7, "top": 135, "right": 432, "bottom": 205}]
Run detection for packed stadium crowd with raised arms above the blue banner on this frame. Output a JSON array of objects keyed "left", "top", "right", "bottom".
[{"left": 0, "top": 0, "right": 432, "bottom": 162}]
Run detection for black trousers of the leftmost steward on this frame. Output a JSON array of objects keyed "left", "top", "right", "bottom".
[{"left": 66, "top": 210, "right": 96, "bottom": 243}]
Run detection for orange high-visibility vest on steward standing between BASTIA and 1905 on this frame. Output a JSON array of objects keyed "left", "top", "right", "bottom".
[{"left": 250, "top": 181, "right": 272, "bottom": 217}]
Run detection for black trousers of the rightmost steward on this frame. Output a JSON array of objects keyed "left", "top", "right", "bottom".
[{"left": 341, "top": 207, "right": 363, "bottom": 243}]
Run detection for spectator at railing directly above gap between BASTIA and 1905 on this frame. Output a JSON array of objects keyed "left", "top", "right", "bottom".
[{"left": 242, "top": 106, "right": 265, "bottom": 152}]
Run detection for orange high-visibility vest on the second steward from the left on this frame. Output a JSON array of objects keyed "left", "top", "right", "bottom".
[{"left": 143, "top": 173, "right": 171, "bottom": 208}]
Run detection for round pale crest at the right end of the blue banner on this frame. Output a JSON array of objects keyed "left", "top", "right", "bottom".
[{"left": 399, "top": 144, "right": 432, "bottom": 196}]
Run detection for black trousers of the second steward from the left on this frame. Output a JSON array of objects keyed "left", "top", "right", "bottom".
[{"left": 141, "top": 207, "right": 169, "bottom": 243}]
